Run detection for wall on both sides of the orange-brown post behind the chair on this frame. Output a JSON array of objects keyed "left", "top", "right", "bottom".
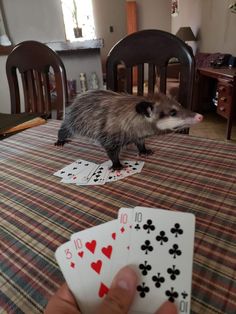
[{"left": 93, "top": 0, "right": 171, "bottom": 67}]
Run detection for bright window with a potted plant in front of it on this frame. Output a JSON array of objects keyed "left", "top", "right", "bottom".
[{"left": 61, "top": 0, "right": 95, "bottom": 41}]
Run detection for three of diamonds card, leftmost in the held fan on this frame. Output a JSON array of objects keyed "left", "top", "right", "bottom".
[{"left": 55, "top": 241, "right": 87, "bottom": 313}]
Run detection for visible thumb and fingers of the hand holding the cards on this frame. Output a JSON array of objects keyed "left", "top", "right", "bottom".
[{"left": 44, "top": 267, "right": 177, "bottom": 314}]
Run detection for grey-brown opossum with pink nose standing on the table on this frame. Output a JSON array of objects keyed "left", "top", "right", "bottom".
[{"left": 55, "top": 90, "right": 203, "bottom": 170}]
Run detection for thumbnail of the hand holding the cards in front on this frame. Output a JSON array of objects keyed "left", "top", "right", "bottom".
[{"left": 112, "top": 266, "right": 138, "bottom": 291}]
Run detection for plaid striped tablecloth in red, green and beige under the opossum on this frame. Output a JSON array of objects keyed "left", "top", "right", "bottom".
[{"left": 0, "top": 121, "right": 236, "bottom": 314}]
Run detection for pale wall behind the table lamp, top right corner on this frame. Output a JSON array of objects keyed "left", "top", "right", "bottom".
[{"left": 171, "top": 0, "right": 236, "bottom": 56}]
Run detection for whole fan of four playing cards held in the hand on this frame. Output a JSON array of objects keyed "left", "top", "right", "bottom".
[{"left": 55, "top": 207, "right": 195, "bottom": 314}]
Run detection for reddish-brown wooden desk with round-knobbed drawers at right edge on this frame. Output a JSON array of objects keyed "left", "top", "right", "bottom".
[{"left": 197, "top": 67, "right": 236, "bottom": 140}]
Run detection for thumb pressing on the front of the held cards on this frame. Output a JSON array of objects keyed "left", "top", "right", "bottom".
[{"left": 97, "top": 266, "right": 138, "bottom": 314}]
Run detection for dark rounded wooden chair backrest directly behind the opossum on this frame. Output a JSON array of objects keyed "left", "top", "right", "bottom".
[{"left": 106, "top": 30, "right": 195, "bottom": 109}]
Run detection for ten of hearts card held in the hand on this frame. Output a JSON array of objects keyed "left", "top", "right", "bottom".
[{"left": 71, "top": 220, "right": 117, "bottom": 314}]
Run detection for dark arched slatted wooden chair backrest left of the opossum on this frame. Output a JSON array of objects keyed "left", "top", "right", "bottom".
[{"left": 6, "top": 41, "right": 68, "bottom": 119}]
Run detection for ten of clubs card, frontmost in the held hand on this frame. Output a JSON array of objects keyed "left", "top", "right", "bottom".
[{"left": 128, "top": 207, "right": 195, "bottom": 314}]
